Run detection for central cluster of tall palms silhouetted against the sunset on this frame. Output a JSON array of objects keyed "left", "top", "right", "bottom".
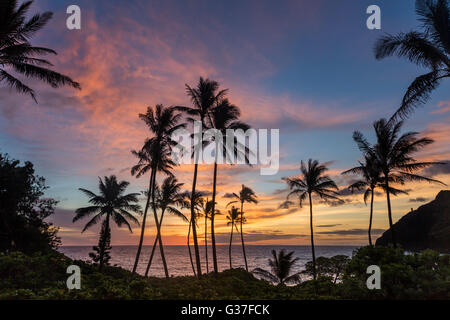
[{"left": 123, "top": 78, "right": 257, "bottom": 277}]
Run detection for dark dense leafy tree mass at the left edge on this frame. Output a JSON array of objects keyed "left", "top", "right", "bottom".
[{"left": 0, "top": 154, "right": 59, "bottom": 253}]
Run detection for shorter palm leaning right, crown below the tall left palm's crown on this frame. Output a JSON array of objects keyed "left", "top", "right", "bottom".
[{"left": 145, "top": 176, "right": 188, "bottom": 276}]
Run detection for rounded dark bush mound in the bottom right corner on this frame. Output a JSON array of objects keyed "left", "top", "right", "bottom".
[{"left": 340, "top": 246, "right": 450, "bottom": 299}]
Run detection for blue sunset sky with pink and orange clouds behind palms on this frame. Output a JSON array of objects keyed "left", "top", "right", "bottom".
[{"left": 0, "top": 0, "right": 450, "bottom": 245}]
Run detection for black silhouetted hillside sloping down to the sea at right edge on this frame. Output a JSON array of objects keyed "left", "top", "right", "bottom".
[{"left": 376, "top": 190, "right": 450, "bottom": 252}]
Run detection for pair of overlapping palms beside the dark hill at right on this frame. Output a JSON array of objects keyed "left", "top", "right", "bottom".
[{"left": 343, "top": 118, "right": 443, "bottom": 246}]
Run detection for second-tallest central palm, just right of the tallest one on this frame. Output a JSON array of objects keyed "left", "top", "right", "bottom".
[{"left": 211, "top": 99, "right": 250, "bottom": 273}]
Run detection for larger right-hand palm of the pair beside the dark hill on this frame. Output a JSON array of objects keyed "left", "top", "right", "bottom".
[{"left": 353, "top": 119, "right": 443, "bottom": 246}]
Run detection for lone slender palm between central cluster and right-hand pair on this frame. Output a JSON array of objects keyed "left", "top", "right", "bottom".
[{"left": 283, "top": 159, "right": 340, "bottom": 280}]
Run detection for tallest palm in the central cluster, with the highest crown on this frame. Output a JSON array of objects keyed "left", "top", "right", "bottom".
[{"left": 177, "top": 77, "right": 227, "bottom": 276}]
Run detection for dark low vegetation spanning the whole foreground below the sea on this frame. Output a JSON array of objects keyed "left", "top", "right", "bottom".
[{"left": 0, "top": 246, "right": 450, "bottom": 300}]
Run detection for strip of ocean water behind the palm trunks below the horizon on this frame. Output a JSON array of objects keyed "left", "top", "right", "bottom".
[{"left": 59, "top": 245, "right": 357, "bottom": 277}]
